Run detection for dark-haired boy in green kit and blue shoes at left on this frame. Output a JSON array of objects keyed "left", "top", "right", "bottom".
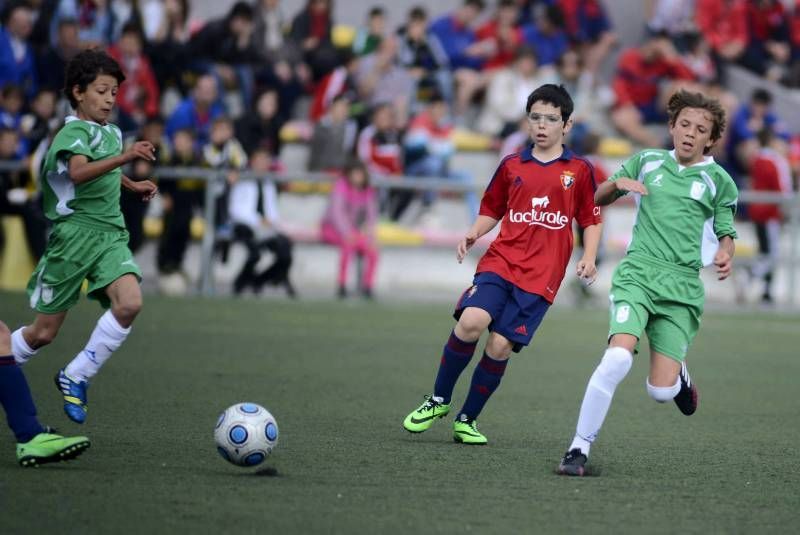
[{"left": 11, "top": 50, "right": 157, "bottom": 423}]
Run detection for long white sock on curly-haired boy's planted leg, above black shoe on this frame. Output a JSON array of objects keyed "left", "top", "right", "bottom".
[{"left": 570, "top": 347, "right": 633, "bottom": 455}]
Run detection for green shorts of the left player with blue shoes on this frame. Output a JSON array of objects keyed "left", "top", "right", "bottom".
[{"left": 28, "top": 222, "right": 142, "bottom": 314}]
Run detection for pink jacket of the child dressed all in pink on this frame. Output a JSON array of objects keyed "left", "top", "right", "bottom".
[{"left": 322, "top": 177, "right": 378, "bottom": 237}]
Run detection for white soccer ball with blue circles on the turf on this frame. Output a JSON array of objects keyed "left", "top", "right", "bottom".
[{"left": 214, "top": 403, "right": 278, "bottom": 466}]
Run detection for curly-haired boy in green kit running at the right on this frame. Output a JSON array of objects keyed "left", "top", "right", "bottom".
[{"left": 557, "top": 91, "right": 738, "bottom": 476}]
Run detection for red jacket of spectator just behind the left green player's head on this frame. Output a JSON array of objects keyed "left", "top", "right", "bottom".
[{"left": 108, "top": 45, "right": 160, "bottom": 117}]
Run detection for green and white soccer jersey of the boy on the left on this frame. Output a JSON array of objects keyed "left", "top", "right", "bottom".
[{"left": 41, "top": 116, "right": 125, "bottom": 230}]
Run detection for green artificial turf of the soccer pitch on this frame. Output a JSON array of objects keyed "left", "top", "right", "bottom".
[{"left": 0, "top": 293, "right": 800, "bottom": 534}]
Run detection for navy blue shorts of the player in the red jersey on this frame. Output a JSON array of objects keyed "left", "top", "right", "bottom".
[{"left": 453, "top": 272, "right": 550, "bottom": 353}]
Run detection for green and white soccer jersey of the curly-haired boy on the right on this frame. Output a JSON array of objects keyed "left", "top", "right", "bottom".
[{"left": 609, "top": 149, "right": 739, "bottom": 270}]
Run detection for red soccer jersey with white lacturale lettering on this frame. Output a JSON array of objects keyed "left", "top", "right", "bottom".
[{"left": 476, "top": 145, "right": 601, "bottom": 303}]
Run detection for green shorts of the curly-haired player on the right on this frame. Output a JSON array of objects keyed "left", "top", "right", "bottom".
[{"left": 608, "top": 255, "right": 705, "bottom": 362}]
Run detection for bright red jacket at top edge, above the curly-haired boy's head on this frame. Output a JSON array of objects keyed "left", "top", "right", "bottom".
[{"left": 695, "top": 0, "right": 749, "bottom": 50}]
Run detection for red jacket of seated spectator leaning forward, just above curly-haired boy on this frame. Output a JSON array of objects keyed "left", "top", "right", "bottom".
[{"left": 612, "top": 48, "right": 694, "bottom": 106}]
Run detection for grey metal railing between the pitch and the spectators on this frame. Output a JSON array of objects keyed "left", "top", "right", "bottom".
[{"left": 0, "top": 160, "right": 800, "bottom": 307}]
